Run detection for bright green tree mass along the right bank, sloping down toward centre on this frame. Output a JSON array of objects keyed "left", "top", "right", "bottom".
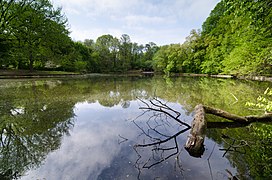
[{"left": 154, "top": 0, "right": 272, "bottom": 75}]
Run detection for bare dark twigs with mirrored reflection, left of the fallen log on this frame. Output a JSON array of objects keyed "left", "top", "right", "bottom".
[{"left": 133, "top": 98, "right": 190, "bottom": 178}]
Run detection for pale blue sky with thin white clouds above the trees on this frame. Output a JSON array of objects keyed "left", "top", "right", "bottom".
[{"left": 52, "top": 0, "right": 220, "bottom": 45}]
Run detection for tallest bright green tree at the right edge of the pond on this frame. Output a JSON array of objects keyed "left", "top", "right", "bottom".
[{"left": 198, "top": 0, "right": 272, "bottom": 75}]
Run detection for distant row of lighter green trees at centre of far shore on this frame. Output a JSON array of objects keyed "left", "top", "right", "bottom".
[{"left": 82, "top": 34, "right": 158, "bottom": 72}]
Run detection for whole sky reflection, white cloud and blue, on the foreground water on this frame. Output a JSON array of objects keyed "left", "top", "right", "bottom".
[{"left": 19, "top": 101, "right": 239, "bottom": 180}]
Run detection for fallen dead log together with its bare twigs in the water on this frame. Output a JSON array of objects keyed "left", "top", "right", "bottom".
[{"left": 133, "top": 98, "right": 272, "bottom": 162}]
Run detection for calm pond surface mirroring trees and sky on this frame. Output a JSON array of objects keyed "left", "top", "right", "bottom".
[{"left": 0, "top": 76, "right": 272, "bottom": 180}]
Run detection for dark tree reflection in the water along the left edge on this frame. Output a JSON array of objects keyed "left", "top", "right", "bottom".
[{"left": 0, "top": 84, "right": 74, "bottom": 179}]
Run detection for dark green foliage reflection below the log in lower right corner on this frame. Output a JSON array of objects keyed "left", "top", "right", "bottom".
[{"left": 207, "top": 117, "right": 272, "bottom": 179}]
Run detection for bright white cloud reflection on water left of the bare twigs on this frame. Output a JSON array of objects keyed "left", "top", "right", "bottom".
[{"left": 23, "top": 103, "right": 138, "bottom": 180}]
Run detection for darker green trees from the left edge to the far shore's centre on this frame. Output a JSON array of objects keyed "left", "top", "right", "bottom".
[{"left": 0, "top": 0, "right": 158, "bottom": 72}]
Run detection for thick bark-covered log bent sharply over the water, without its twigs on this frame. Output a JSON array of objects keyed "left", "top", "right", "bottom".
[{"left": 185, "top": 104, "right": 272, "bottom": 157}]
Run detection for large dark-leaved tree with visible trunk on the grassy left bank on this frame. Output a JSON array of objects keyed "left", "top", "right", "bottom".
[{"left": 12, "top": 0, "right": 69, "bottom": 71}]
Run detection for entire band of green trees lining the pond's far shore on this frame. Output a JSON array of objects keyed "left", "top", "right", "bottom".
[{"left": 0, "top": 0, "right": 272, "bottom": 76}]
